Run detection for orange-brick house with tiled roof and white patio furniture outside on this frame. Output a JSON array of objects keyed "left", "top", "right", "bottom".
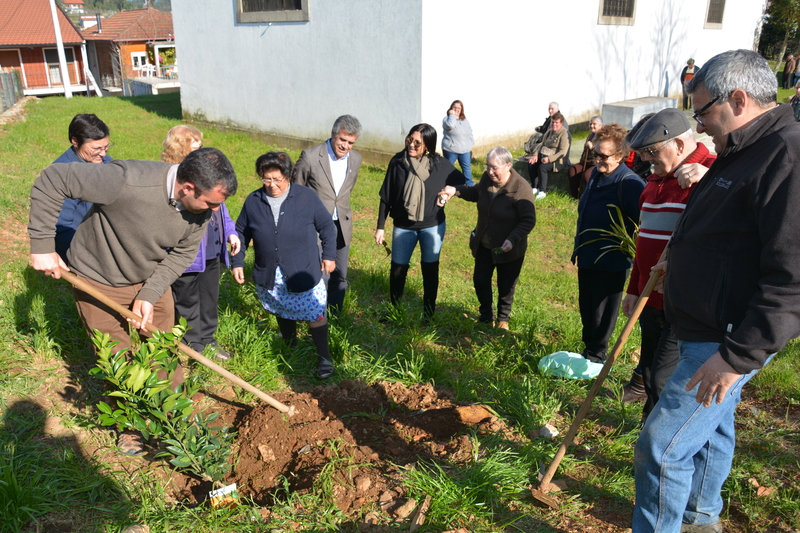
[{"left": 82, "top": 7, "right": 177, "bottom": 89}]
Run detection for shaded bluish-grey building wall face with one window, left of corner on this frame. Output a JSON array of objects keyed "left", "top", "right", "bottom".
[{"left": 172, "top": 0, "right": 422, "bottom": 152}]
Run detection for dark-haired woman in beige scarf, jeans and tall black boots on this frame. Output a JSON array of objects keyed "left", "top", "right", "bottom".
[{"left": 375, "top": 124, "right": 466, "bottom": 318}]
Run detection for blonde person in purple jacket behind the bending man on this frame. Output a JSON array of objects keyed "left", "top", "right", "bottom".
[{"left": 166, "top": 125, "right": 241, "bottom": 361}]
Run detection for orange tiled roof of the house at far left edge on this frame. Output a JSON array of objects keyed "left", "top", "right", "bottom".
[{"left": 0, "top": 0, "right": 83, "bottom": 46}]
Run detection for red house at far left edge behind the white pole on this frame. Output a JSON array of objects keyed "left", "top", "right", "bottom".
[{"left": 0, "top": 0, "right": 86, "bottom": 95}]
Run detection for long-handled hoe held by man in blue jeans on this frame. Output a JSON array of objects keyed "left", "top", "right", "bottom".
[{"left": 531, "top": 248, "right": 667, "bottom": 509}]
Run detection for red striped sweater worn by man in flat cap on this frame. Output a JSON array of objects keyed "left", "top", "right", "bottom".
[{"left": 628, "top": 144, "right": 717, "bottom": 309}]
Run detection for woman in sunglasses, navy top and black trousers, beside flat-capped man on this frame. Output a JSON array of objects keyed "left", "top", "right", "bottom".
[{"left": 572, "top": 124, "right": 645, "bottom": 363}]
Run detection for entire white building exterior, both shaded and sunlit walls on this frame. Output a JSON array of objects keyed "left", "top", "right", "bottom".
[{"left": 173, "top": 0, "right": 764, "bottom": 152}]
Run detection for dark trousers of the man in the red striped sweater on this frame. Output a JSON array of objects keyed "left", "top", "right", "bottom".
[{"left": 639, "top": 305, "right": 681, "bottom": 420}]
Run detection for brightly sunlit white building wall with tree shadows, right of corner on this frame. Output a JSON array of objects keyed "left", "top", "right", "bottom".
[{"left": 422, "top": 0, "right": 763, "bottom": 155}]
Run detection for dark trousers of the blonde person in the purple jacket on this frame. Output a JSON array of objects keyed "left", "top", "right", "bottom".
[{"left": 172, "top": 257, "right": 220, "bottom": 352}]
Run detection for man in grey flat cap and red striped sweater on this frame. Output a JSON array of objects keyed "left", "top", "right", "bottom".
[{"left": 622, "top": 108, "right": 716, "bottom": 412}]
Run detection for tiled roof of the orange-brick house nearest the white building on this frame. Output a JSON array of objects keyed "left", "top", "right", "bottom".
[{"left": 83, "top": 7, "right": 172, "bottom": 42}]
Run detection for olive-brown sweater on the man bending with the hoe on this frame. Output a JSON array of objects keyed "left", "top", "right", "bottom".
[{"left": 28, "top": 160, "right": 211, "bottom": 304}]
